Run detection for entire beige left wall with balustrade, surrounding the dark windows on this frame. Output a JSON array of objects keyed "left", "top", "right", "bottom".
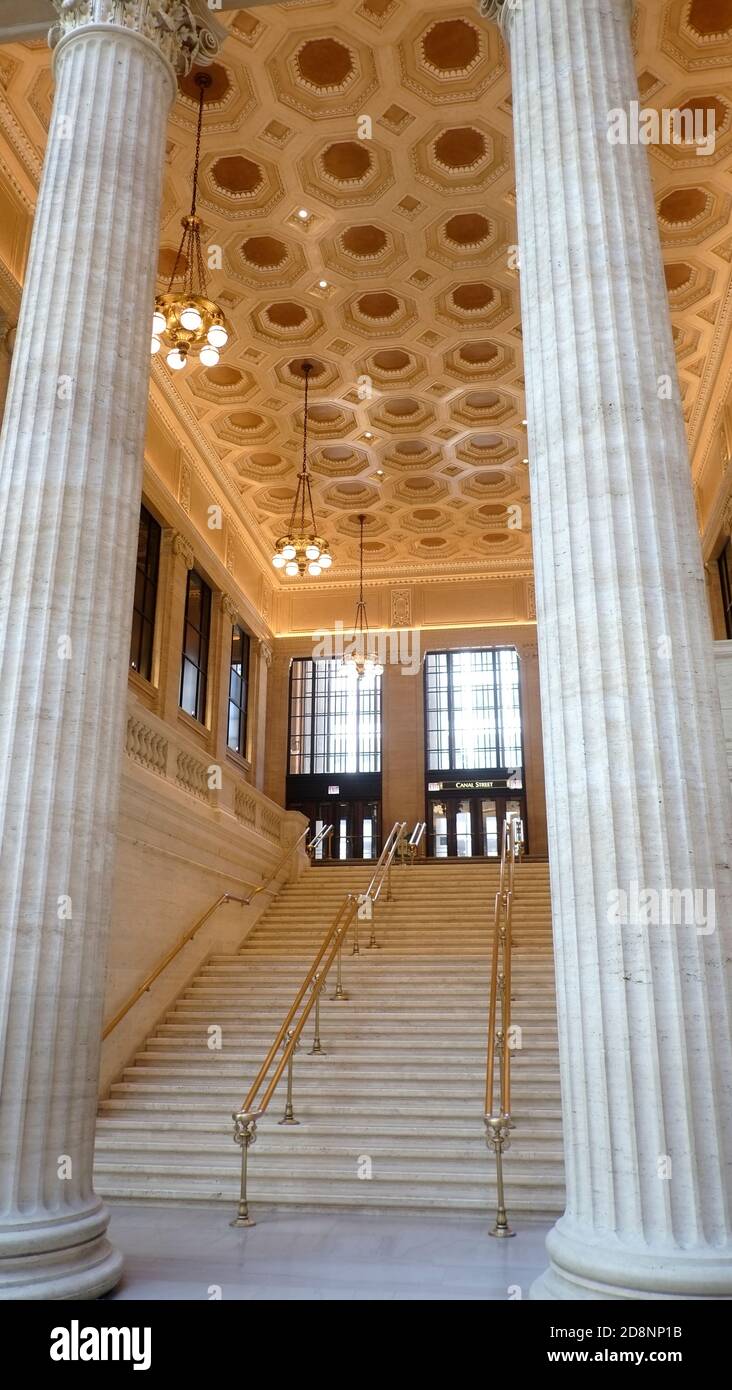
[{"left": 100, "top": 455, "right": 294, "bottom": 1094}]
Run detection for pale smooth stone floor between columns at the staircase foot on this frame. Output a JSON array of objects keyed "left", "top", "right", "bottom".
[{"left": 101, "top": 1202, "right": 549, "bottom": 1301}]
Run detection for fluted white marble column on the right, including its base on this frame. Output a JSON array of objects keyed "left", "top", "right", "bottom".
[{"left": 483, "top": 0, "right": 732, "bottom": 1298}]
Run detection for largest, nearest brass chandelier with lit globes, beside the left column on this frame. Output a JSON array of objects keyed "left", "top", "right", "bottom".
[{"left": 150, "top": 72, "right": 229, "bottom": 371}]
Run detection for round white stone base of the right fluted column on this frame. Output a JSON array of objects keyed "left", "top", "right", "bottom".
[{"left": 529, "top": 1222, "right": 732, "bottom": 1302}]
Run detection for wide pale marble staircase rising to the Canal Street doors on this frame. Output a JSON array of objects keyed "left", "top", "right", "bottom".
[{"left": 96, "top": 860, "right": 564, "bottom": 1216}]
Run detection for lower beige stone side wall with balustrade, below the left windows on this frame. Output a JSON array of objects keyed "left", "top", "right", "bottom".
[{"left": 100, "top": 696, "right": 308, "bottom": 1094}]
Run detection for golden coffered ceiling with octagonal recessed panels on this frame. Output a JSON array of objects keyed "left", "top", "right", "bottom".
[{"left": 0, "top": 0, "right": 732, "bottom": 603}]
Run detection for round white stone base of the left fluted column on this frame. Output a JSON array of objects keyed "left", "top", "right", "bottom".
[{"left": 0, "top": 1204, "right": 122, "bottom": 1301}]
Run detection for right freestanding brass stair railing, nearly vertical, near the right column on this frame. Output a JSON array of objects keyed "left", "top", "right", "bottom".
[{"left": 485, "top": 816, "right": 524, "bottom": 1238}]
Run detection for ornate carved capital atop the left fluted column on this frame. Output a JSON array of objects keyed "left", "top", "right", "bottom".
[{"left": 49, "top": 0, "right": 225, "bottom": 72}]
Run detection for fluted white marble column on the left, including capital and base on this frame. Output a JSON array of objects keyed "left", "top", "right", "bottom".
[{"left": 0, "top": 0, "right": 220, "bottom": 1298}]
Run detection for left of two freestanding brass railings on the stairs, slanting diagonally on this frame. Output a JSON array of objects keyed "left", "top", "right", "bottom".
[{"left": 231, "top": 820, "right": 407, "bottom": 1226}]
